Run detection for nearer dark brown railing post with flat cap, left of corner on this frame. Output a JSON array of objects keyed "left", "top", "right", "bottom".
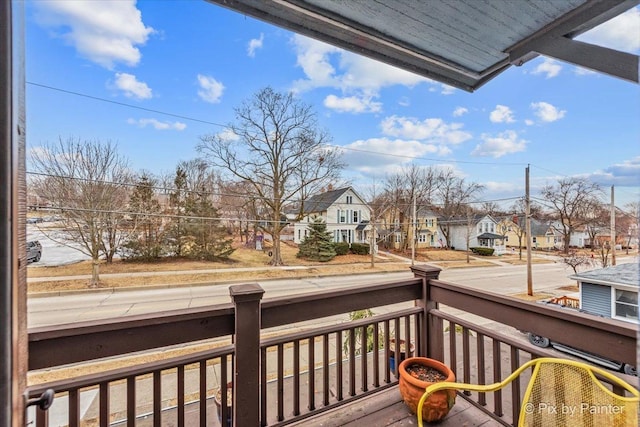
[{"left": 229, "top": 283, "right": 264, "bottom": 426}]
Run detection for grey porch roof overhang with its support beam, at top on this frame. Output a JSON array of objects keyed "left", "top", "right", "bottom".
[{"left": 208, "top": 0, "right": 640, "bottom": 91}]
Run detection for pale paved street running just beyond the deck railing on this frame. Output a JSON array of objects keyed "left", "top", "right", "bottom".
[{"left": 28, "top": 261, "right": 600, "bottom": 327}]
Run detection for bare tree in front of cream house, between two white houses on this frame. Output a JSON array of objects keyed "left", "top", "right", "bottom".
[{"left": 436, "top": 169, "right": 484, "bottom": 248}]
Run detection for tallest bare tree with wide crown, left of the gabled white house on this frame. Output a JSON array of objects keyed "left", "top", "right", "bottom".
[{"left": 198, "top": 87, "right": 344, "bottom": 265}]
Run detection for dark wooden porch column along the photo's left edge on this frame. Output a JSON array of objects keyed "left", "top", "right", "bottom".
[{"left": 0, "top": 1, "right": 28, "bottom": 427}]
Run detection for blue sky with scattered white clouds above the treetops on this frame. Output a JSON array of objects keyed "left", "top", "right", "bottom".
[{"left": 25, "top": 0, "right": 640, "bottom": 211}]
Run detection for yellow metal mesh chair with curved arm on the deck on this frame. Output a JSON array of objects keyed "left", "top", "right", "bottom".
[{"left": 416, "top": 357, "right": 640, "bottom": 427}]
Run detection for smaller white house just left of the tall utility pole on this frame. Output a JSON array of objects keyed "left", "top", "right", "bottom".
[{"left": 438, "top": 215, "right": 506, "bottom": 255}]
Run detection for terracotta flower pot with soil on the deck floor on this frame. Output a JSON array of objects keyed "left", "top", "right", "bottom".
[{"left": 398, "top": 357, "right": 456, "bottom": 422}]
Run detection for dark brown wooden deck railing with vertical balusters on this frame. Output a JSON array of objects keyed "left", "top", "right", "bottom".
[{"left": 29, "top": 266, "right": 636, "bottom": 427}]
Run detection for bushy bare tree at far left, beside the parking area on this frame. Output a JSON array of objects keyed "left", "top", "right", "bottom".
[{"left": 30, "top": 138, "right": 131, "bottom": 286}]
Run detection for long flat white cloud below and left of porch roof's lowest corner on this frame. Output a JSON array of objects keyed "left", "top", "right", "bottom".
[{"left": 380, "top": 116, "right": 471, "bottom": 145}]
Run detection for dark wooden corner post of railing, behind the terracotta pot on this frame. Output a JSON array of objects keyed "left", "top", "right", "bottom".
[{"left": 411, "top": 265, "right": 444, "bottom": 361}]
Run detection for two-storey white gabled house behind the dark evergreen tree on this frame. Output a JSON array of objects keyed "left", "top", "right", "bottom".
[{"left": 293, "top": 187, "right": 371, "bottom": 243}]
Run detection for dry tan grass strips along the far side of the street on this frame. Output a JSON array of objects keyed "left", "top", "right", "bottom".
[{"left": 27, "top": 242, "right": 549, "bottom": 294}]
